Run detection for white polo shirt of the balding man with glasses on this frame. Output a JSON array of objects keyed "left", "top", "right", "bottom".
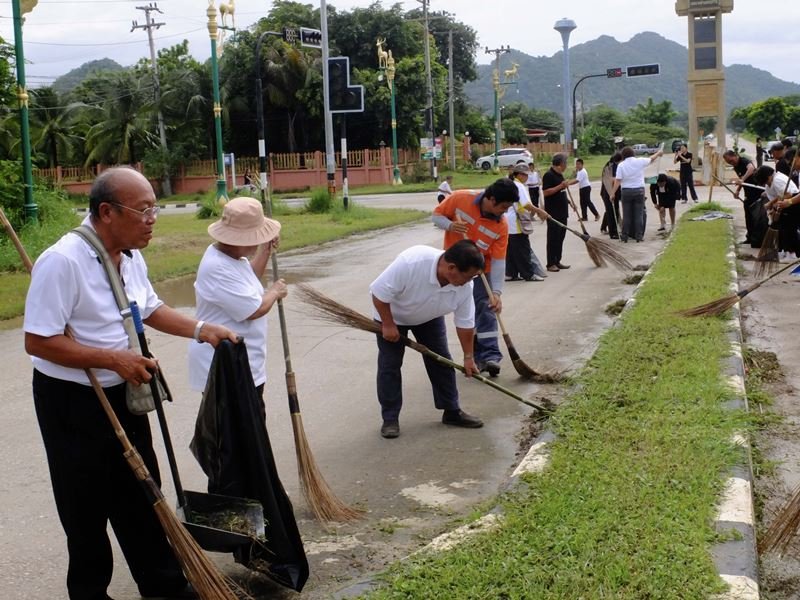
[{"left": 23, "top": 216, "right": 163, "bottom": 387}]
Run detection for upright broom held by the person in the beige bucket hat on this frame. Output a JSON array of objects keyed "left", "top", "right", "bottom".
[{"left": 261, "top": 187, "right": 364, "bottom": 522}]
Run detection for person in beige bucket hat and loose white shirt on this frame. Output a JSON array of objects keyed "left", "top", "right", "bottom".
[{"left": 189, "top": 197, "right": 286, "bottom": 398}]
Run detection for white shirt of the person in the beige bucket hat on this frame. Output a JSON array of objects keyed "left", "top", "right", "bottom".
[{"left": 189, "top": 244, "right": 267, "bottom": 392}]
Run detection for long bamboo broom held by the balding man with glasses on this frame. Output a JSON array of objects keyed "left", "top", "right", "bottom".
[{"left": 0, "top": 208, "right": 244, "bottom": 600}]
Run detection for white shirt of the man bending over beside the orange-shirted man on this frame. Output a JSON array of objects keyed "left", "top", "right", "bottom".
[{"left": 369, "top": 246, "right": 475, "bottom": 329}]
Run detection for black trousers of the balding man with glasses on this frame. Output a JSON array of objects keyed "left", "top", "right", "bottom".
[{"left": 33, "top": 370, "right": 186, "bottom": 600}]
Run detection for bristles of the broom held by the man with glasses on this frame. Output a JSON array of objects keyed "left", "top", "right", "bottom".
[{"left": 153, "top": 497, "right": 245, "bottom": 600}]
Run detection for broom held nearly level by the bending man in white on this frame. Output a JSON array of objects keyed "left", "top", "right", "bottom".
[{"left": 297, "top": 283, "right": 564, "bottom": 400}]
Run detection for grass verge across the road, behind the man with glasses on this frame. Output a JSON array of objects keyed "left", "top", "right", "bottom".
[{"left": 0, "top": 204, "right": 428, "bottom": 319}]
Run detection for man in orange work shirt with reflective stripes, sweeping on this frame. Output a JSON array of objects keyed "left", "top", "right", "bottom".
[{"left": 432, "top": 178, "right": 519, "bottom": 377}]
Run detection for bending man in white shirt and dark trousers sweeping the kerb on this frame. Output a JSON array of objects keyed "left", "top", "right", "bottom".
[{"left": 370, "top": 240, "right": 484, "bottom": 439}]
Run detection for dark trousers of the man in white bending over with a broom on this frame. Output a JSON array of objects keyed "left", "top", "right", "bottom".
[{"left": 377, "top": 317, "right": 459, "bottom": 421}]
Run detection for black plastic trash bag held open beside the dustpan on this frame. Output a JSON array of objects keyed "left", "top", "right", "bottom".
[{"left": 190, "top": 341, "right": 308, "bottom": 592}]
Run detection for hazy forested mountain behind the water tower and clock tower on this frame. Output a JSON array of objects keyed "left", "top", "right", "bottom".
[{"left": 465, "top": 31, "right": 800, "bottom": 114}]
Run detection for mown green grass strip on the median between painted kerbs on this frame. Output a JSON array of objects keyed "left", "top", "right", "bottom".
[{"left": 368, "top": 204, "right": 745, "bottom": 600}]
